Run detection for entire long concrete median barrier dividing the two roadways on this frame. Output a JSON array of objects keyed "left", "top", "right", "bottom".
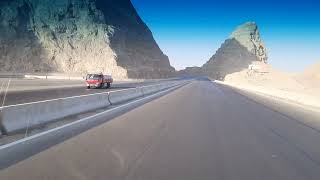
[{"left": 0, "top": 81, "right": 188, "bottom": 134}]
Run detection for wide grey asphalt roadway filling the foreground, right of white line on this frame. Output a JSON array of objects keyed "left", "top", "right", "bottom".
[{"left": 0, "top": 81, "right": 320, "bottom": 180}]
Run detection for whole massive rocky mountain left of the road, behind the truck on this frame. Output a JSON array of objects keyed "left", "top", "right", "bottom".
[{"left": 0, "top": 0, "right": 175, "bottom": 78}]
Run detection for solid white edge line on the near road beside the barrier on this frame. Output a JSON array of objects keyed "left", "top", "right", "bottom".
[{"left": 0, "top": 85, "right": 185, "bottom": 151}]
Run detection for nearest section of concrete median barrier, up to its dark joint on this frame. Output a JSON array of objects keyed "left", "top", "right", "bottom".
[{"left": 1, "top": 93, "right": 110, "bottom": 134}]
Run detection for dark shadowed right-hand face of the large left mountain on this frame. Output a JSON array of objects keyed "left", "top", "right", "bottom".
[{"left": 97, "top": 0, "right": 175, "bottom": 77}]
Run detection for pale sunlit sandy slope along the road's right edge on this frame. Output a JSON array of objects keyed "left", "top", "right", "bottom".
[{"left": 225, "top": 63, "right": 320, "bottom": 107}]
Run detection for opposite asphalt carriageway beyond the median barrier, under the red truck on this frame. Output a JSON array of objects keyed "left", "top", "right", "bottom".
[{"left": 0, "top": 79, "right": 169, "bottom": 105}]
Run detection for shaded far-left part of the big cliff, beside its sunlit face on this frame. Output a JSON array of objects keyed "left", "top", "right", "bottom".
[{"left": 0, "top": 0, "right": 50, "bottom": 72}]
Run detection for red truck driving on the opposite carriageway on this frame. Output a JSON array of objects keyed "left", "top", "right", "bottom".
[{"left": 86, "top": 74, "right": 113, "bottom": 89}]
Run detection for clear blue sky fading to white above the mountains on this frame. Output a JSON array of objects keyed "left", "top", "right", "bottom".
[{"left": 132, "top": 0, "right": 320, "bottom": 71}]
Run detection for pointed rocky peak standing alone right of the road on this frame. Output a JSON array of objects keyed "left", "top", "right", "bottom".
[{"left": 202, "top": 22, "right": 268, "bottom": 79}]
